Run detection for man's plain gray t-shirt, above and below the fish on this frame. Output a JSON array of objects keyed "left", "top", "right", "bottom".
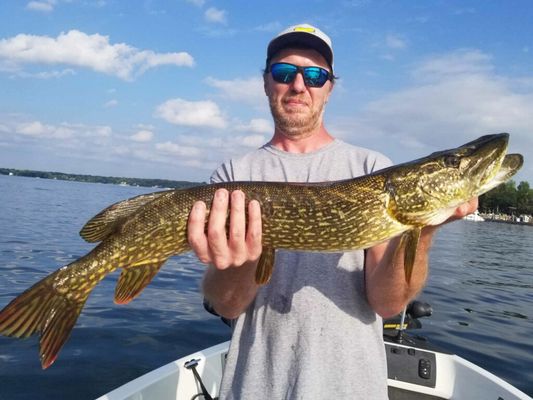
[{"left": 211, "top": 139, "right": 391, "bottom": 400}]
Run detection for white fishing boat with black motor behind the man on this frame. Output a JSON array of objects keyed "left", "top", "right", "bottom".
[{"left": 97, "top": 301, "right": 533, "bottom": 400}]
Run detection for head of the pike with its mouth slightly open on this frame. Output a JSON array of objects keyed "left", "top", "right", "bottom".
[{"left": 386, "top": 133, "right": 523, "bottom": 226}]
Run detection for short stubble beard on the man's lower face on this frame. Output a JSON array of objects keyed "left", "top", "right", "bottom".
[{"left": 269, "top": 98, "right": 324, "bottom": 139}]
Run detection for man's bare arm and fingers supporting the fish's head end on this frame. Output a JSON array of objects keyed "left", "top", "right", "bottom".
[{"left": 365, "top": 198, "right": 478, "bottom": 318}]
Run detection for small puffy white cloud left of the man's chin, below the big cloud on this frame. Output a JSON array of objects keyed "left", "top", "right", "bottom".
[{"left": 155, "top": 98, "right": 227, "bottom": 128}]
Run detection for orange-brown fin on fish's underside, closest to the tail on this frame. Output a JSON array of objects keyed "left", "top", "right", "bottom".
[{"left": 115, "top": 260, "right": 166, "bottom": 304}]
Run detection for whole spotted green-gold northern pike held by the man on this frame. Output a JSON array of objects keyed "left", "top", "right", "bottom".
[{"left": 0, "top": 133, "right": 523, "bottom": 369}]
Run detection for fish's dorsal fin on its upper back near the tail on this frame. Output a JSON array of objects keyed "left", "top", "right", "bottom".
[{"left": 80, "top": 191, "right": 169, "bottom": 243}]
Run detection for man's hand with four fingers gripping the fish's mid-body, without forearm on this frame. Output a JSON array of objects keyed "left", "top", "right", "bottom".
[{"left": 187, "top": 189, "right": 262, "bottom": 270}]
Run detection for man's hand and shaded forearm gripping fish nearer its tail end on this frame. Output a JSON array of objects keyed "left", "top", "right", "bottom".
[{"left": 187, "top": 189, "right": 262, "bottom": 319}]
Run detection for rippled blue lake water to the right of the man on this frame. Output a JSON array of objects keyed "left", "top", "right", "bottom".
[{"left": 420, "top": 221, "right": 533, "bottom": 396}]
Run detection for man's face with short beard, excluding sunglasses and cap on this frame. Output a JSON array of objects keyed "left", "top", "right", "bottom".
[{"left": 264, "top": 49, "right": 333, "bottom": 139}]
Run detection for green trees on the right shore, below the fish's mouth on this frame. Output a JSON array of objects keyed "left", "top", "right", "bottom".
[{"left": 479, "top": 180, "right": 533, "bottom": 215}]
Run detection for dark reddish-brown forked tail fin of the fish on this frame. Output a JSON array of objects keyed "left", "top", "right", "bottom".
[{"left": 0, "top": 270, "right": 90, "bottom": 369}]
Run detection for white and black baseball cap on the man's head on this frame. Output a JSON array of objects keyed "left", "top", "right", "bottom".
[{"left": 267, "top": 24, "right": 333, "bottom": 72}]
